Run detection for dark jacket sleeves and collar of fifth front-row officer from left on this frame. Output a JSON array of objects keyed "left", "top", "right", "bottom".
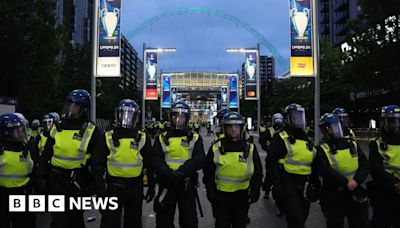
[{"left": 203, "top": 138, "right": 263, "bottom": 192}]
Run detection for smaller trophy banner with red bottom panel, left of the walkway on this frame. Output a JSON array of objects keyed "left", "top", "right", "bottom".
[{"left": 144, "top": 51, "right": 158, "bottom": 100}]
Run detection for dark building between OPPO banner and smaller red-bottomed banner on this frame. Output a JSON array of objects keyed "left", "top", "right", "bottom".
[{"left": 120, "top": 35, "right": 143, "bottom": 98}]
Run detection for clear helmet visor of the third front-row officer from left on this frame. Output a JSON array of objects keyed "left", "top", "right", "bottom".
[{"left": 115, "top": 107, "right": 139, "bottom": 128}]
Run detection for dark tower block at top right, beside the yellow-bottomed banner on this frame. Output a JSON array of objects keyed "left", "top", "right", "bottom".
[{"left": 318, "top": 0, "right": 361, "bottom": 46}]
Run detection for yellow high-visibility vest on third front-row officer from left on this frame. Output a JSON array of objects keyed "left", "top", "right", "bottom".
[{"left": 105, "top": 130, "right": 146, "bottom": 178}]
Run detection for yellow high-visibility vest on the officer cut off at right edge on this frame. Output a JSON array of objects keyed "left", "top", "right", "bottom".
[{"left": 375, "top": 137, "right": 400, "bottom": 179}]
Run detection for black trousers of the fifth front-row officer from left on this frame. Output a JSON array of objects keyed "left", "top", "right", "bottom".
[{"left": 214, "top": 190, "right": 249, "bottom": 228}]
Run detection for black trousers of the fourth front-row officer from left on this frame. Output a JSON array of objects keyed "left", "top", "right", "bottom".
[{"left": 154, "top": 186, "right": 198, "bottom": 228}]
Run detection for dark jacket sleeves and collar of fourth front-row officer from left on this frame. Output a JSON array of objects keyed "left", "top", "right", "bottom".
[{"left": 153, "top": 130, "right": 205, "bottom": 186}]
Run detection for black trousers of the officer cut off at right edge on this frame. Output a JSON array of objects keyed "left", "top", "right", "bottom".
[{"left": 371, "top": 189, "right": 400, "bottom": 228}]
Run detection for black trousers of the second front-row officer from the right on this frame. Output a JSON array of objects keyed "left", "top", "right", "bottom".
[{"left": 320, "top": 188, "right": 369, "bottom": 228}]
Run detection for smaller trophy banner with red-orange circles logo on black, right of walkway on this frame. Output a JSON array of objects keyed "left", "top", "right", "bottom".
[{"left": 244, "top": 51, "right": 258, "bottom": 100}]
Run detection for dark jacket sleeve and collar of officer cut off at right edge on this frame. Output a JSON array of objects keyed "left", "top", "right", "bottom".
[{"left": 369, "top": 134, "right": 400, "bottom": 191}]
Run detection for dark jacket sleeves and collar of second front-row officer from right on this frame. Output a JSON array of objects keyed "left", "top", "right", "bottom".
[{"left": 317, "top": 139, "right": 369, "bottom": 188}]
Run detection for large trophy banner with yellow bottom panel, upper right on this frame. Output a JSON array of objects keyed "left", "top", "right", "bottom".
[{"left": 289, "top": 0, "right": 315, "bottom": 76}]
